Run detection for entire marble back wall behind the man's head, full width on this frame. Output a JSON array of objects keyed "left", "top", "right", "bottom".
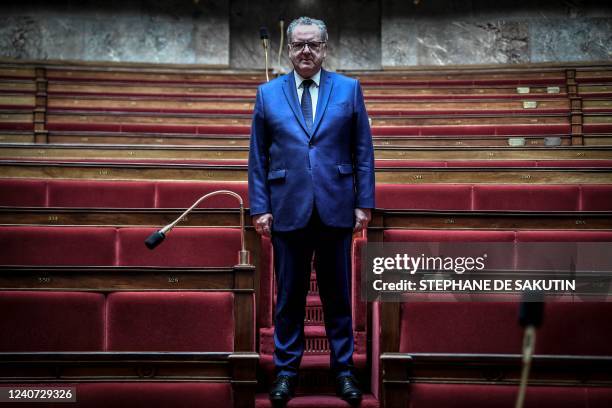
[{"left": 0, "top": 0, "right": 612, "bottom": 70}]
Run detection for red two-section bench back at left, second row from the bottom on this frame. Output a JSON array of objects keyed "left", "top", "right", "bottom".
[{"left": 0, "top": 291, "right": 234, "bottom": 352}]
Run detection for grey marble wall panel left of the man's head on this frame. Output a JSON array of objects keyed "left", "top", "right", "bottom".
[{"left": 0, "top": 0, "right": 229, "bottom": 65}]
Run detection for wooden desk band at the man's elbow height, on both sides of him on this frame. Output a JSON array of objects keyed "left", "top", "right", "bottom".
[{"left": 0, "top": 160, "right": 612, "bottom": 184}]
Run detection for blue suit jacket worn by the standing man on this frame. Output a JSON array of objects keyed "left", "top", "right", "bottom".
[{"left": 249, "top": 70, "right": 374, "bottom": 231}]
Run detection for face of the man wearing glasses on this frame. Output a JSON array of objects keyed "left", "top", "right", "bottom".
[{"left": 288, "top": 25, "right": 327, "bottom": 78}]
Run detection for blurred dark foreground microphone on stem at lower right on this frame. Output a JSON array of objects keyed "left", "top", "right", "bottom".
[{"left": 515, "top": 291, "right": 544, "bottom": 408}]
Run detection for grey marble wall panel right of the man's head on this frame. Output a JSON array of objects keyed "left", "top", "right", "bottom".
[{"left": 381, "top": 0, "right": 612, "bottom": 67}]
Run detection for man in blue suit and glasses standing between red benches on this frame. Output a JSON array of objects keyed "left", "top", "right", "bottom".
[{"left": 249, "top": 17, "right": 374, "bottom": 406}]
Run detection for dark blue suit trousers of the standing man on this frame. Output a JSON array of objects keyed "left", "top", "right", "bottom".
[{"left": 272, "top": 208, "right": 354, "bottom": 376}]
